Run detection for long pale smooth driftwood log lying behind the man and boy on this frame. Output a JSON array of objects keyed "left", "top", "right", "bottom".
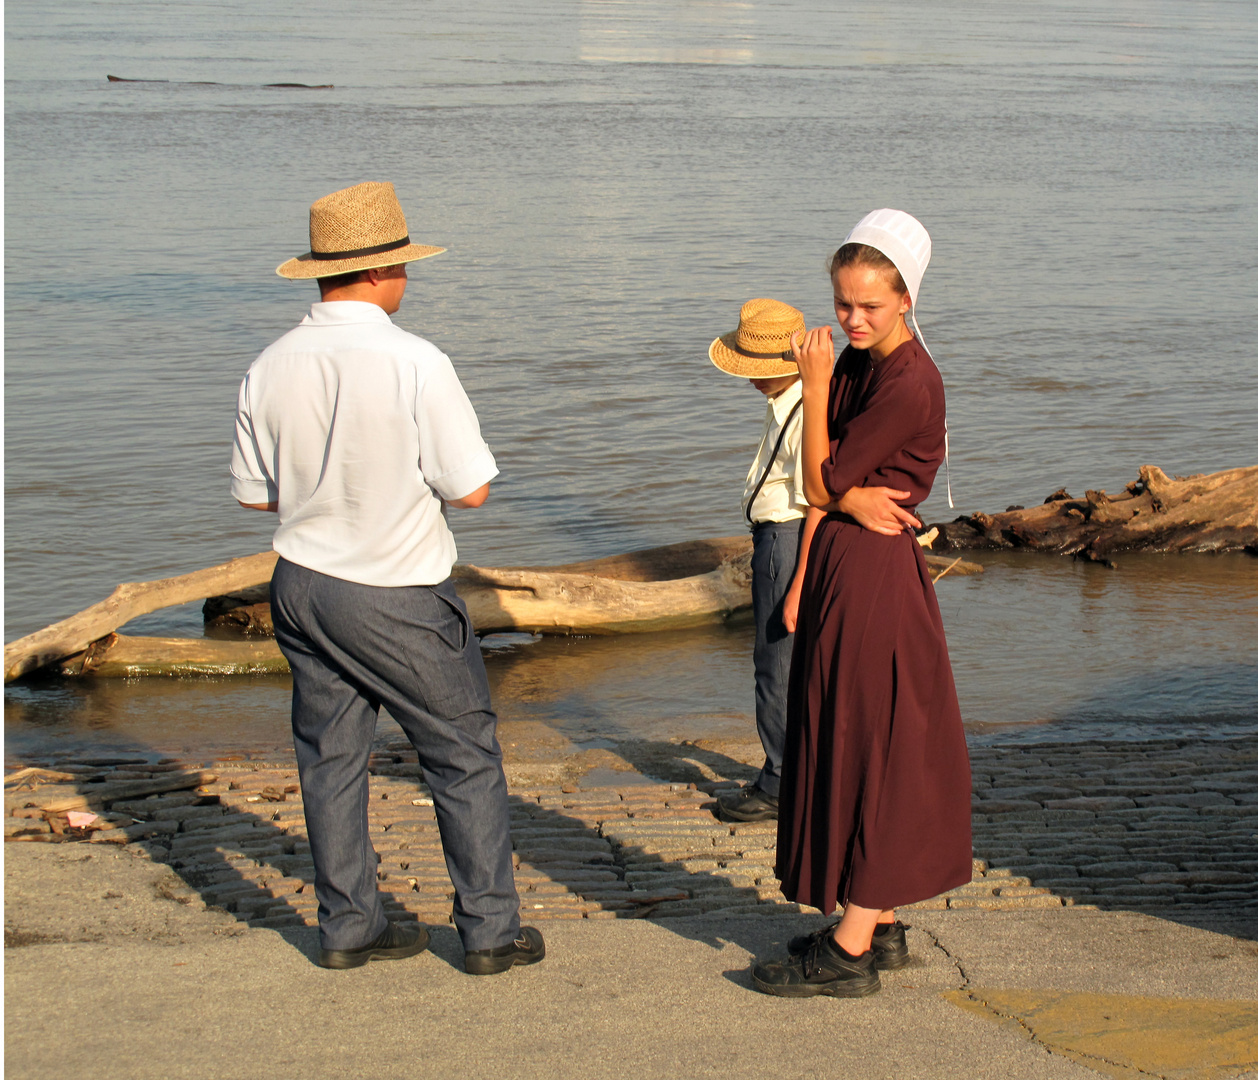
[{"left": 5, "top": 536, "right": 982, "bottom": 683}]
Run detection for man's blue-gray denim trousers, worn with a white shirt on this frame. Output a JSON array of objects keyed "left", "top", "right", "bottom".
[{"left": 270, "top": 558, "right": 520, "bottom": 949}]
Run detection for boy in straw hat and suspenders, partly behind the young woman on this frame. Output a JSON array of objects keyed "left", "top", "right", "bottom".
[{"left": 708, "top": 299, "right": 821, "bottom": 821}]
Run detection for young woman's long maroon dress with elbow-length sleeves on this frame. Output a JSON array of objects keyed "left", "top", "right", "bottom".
[{"left": 777, "top": 338, "right": 971, "bottom": 913}]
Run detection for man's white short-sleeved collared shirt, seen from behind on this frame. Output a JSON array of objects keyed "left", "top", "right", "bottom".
[{"left": 231, "top": 300, "right": 498, "bottom": 586}]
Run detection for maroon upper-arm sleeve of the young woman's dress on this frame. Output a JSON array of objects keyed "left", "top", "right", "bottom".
[{"left": 821, "top": 367, "right": 930, "bottom": 499}]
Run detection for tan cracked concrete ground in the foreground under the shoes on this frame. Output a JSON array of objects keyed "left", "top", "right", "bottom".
[{"left": 5, "top": 844, "right": 1258, "bottom": 1080}]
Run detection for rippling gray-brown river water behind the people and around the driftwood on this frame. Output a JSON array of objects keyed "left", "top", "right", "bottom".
[{"left": 5, "top": 0, "right": 1258, "bottom": 749}]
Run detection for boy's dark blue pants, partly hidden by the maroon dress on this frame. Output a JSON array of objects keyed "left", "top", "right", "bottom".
[{"left": 751, "top": 519, "right": 804, "bottom": 796}]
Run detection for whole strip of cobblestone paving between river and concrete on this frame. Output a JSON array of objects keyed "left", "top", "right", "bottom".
[{"left": 5, "top": 738, "right": 1258, "bottom": 928}]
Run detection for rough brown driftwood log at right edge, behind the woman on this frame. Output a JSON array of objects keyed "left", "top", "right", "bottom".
[{"left": 935, "top": 465, "right": 1258, "bottom": 565}]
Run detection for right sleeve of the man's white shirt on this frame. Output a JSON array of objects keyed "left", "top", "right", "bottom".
[{"left": 415, "top": 352, "right": 498, "bottom": 499}]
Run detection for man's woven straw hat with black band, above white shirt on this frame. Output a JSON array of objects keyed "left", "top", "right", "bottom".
[{"left": 276, "top": 182, "right": 445, "bottom": 278}]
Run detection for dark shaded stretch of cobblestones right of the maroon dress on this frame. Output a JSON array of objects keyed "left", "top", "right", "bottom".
[{"left": 972, "top": 737, "right": 1258, "bottom": 922}]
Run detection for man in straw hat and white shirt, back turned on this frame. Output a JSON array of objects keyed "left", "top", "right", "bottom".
[{"left": 231, "top": 184, "right": 546, "bottom": 974}]
